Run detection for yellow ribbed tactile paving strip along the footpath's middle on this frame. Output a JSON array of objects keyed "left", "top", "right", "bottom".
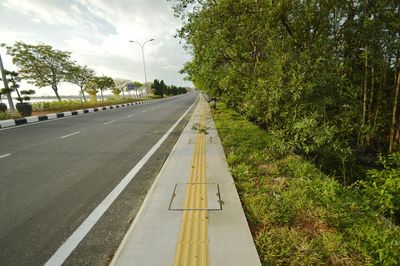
[{"left": 174, "top": 99, "right": 209, "bottom": 266}]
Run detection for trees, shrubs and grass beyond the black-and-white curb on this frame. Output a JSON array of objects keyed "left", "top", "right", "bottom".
[{"left": 0, "top": 41, "right": 187, "bottom": 118}]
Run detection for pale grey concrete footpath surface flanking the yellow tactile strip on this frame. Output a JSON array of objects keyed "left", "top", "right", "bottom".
[{"left": 110, "top": 98, "right": 261, "bottom": 266}]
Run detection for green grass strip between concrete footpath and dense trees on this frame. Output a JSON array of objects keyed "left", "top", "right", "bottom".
[{"left": 213, "top": 103, "right": 400, "bottom": 265}]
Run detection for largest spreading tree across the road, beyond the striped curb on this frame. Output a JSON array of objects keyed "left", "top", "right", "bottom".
[{"left": 7, "top": 42, "right": 72, "bottom": 101}]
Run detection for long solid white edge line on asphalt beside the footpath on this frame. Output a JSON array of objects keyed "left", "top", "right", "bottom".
[{"left": 45, "top": 98, "right": 196, "bottom": 266}]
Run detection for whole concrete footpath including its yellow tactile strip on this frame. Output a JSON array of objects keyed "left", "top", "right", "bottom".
[{"left": 110, "top": 96, "right": 261, "bottom": 266}]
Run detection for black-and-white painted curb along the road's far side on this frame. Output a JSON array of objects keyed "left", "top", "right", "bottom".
[{"left": 0, "top": 100, "right": 152, "bottom": 128}]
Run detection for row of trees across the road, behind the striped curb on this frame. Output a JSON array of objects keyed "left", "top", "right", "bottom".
[{"left": 0, "top": 42, "right": 147, "bottom": 102}]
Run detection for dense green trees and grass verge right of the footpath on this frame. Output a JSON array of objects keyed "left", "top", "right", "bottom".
[{"left": 171, "top": 0, "right": 400, "bottom": 265}]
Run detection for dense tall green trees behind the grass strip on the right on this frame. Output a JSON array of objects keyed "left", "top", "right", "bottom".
[{"left": 175, "top": 0, "right": 400, "bottom": 183}]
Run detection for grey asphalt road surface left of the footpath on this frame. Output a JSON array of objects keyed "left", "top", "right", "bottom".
[{"left": 0, "top": 93, "right": 197, "bottom": 265}]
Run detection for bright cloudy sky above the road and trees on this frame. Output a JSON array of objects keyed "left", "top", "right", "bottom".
[{"left": 0, "top": 0, "right": 192, "bottom": 95}]
